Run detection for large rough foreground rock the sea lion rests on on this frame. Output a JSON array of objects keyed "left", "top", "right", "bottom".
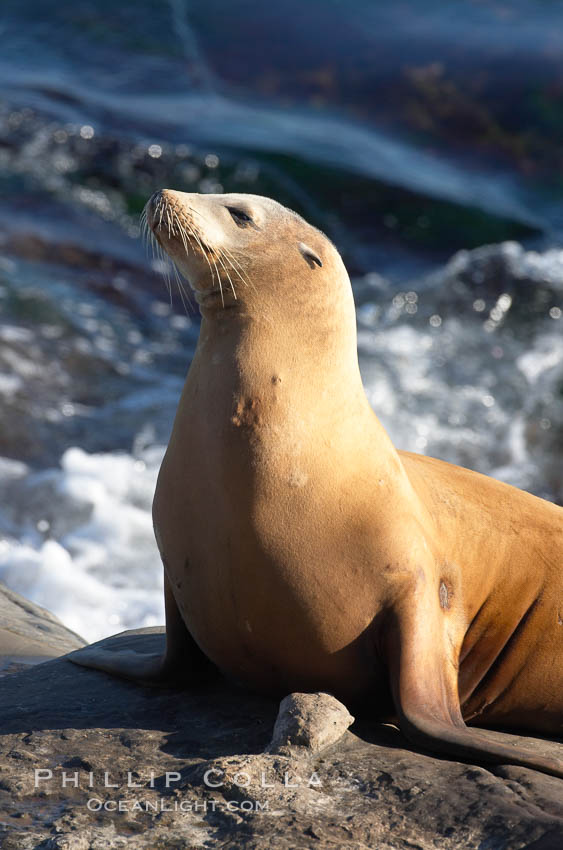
[{"left": 0, "top": 629, "right": 563, "bottom": 850}]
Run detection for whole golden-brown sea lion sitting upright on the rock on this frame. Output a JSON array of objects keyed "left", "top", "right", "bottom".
[{"left": 73, "top": 190, "right": 563, "bottom": 776}]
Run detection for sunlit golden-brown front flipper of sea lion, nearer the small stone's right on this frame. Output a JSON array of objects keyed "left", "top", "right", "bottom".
[{"left": 387, "top": 610, "right": 563, "bottom": 778}]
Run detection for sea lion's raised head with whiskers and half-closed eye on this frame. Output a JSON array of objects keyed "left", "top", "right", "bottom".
[{"left": 145, "top": 189, "right": 353, "bottom": 319}]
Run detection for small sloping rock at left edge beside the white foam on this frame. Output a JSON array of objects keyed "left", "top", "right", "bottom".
[{"left": 0, "top": 583, "right": 86, "bottom": 676}]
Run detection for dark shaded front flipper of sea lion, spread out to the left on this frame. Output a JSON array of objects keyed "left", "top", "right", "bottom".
[{"left": 66, "top": 573, "right": 215, "bottom": 685}]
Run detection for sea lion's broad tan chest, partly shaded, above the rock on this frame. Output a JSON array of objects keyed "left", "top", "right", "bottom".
[{"left": 153, "top": 380, "right": 382, "bottom": 698}]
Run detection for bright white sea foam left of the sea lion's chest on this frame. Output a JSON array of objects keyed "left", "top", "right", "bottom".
[{"left": 0, "top": 448, "right": 164, "bottom": 640}]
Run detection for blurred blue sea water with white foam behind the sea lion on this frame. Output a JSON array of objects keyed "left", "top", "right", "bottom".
[{"left": 0, "top": 0, "right": 563, "bottom": 639}]
